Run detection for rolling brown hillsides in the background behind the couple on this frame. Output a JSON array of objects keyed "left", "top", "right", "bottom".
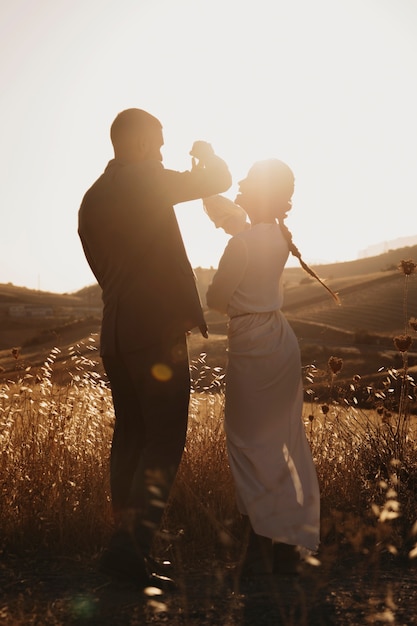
[{"left": 0, "top": 241, "right": 417, "bottom": 388}]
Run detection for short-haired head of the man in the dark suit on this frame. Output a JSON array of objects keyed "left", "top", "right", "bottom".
[{"left": 110, "top": 109, "right": 164, "bottom": 162}]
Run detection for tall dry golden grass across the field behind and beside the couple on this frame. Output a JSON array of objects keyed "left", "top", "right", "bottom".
[{"left": 0, "top": 258, "right": 417, "bottom": 626}]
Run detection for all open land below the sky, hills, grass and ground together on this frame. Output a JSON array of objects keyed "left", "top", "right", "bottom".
[{"left": 0, "top": 246, "right": 417, "bottom": 626}]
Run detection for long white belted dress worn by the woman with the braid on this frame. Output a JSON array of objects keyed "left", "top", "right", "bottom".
[{"left": 207, "top": 223, "right": 320, "bottom": 551}]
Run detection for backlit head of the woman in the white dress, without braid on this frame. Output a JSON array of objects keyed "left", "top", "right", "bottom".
[{"left": 235, "top": 159, "right": 294, "bottom": 223}]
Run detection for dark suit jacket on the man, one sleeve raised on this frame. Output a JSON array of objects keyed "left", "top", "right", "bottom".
[{"left": 78, "top": 157, "right": 231, "bottom": 355}]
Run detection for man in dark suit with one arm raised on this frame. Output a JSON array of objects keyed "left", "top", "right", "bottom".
[{"left": 78, "top": 109, "right": 232, "bottom": 585}]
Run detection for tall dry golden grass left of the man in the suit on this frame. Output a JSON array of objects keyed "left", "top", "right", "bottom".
[{"left": 0, "top": 342, "right": 113, "bottom": 550}]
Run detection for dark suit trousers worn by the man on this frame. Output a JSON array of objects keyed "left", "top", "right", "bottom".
[{"left": 103, "top": 336, "right": 190, "bottom": 554}]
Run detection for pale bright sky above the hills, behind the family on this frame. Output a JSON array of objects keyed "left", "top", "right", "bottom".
[{"left": 0, "top": 0, "right": 417, "bottom": 293}]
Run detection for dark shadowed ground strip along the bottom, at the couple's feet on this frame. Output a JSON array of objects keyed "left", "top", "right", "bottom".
[{"left": 0, "top": 554, "right": 417, "bottom": 626}]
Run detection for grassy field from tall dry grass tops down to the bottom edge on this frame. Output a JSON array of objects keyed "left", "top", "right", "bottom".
[{"left": 0, "top": 341, "right": 417, "bottom": 626}]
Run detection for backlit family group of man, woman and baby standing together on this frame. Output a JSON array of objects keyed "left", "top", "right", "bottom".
[{"left": 78, "top": 109, "right": 336, "bottom": 588}]
